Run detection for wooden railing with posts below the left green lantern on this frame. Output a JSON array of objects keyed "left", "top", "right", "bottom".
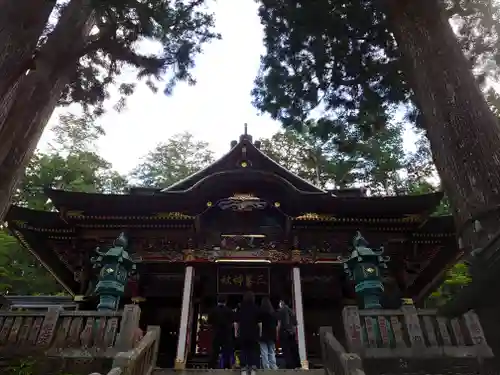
[{"left": 0, "top": 305, "right": 140, "bottom": 359}]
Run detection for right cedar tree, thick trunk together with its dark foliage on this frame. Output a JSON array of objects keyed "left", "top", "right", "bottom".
[{"left": 253, "top": 0, "right": 500, "bottom": 250}]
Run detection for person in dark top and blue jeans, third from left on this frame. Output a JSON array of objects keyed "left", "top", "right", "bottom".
[{"left": 259, "top": 297, "right": 278, "bottom": 370}]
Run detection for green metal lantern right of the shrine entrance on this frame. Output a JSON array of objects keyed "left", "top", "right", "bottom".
[{"left": 342, "top": 232, "right": 390, "bottom": 309}]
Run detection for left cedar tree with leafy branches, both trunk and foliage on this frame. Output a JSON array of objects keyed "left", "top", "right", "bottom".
[{"left": 0, "top": 0, "right": 218, "bottom": 222}]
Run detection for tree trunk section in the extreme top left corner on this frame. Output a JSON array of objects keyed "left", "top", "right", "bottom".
[{"left": 0, "top": 0, "right": 56, "bottom": 98}]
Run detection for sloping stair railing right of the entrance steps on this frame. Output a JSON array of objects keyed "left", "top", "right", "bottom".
[{"left": 319, "top": 327, "right": 364, "bottom": 375}]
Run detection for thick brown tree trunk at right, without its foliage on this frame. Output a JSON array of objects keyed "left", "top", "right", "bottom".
[{"left": 381, "top": 0, "right": 500, "bottom": 251}]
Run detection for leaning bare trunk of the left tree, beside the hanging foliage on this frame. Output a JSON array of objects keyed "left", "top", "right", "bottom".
[{"left": 0, "top": 0, "right": 92, "bottom": 219}]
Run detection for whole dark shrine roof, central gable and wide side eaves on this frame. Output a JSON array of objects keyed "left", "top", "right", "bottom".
[{"left": 13, "top": 134, "right": 442, "bottom": 220}]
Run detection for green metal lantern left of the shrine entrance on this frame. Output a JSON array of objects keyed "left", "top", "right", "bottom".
[{"left": 92, "top": 233, "right": 136, "bottom": 311}]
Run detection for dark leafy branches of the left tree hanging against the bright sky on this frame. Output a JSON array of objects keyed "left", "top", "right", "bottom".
[{"left": 55, "top": 0, "right": 219, "bottom": 115}]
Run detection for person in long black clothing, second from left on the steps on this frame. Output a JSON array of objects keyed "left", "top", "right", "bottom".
[{"left": 236, "top": 292, "right": 261, "bottom": 375}]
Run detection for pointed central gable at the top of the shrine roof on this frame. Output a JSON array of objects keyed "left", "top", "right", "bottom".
[{"left": 161, "top": 134, "right": 325, "bottom": 194}]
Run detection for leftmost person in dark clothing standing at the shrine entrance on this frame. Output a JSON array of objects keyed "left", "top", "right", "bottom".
[{"left": 208, "top": 296, "right": 234, "bottom": 369}]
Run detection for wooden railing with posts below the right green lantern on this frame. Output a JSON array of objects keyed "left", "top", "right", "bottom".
[{"left": 343, "top": 305, "right": 493, "bottom": 358}]
